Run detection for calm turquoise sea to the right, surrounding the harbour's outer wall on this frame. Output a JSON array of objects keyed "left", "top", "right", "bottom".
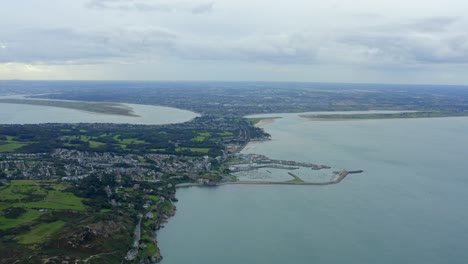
[{"left": 158, "top": 114, "right": 468, "bottom": 264}]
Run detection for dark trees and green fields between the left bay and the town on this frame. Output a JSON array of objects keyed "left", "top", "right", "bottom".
[{"left": 0, "top": 116, "right": 266, "bottom": 157}]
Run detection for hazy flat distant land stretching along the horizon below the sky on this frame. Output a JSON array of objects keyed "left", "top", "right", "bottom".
[{"left": 0, "top": 81, "right": 468, "bottom": 117}]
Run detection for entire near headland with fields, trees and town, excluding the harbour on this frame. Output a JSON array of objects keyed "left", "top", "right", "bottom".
[{"left": 0, "top": 115, "right": 268, "bottom": 263}]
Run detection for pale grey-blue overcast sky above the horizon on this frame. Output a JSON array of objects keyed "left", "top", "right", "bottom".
[{"left": 0, "top": 0, "right": 468, "bottom": 84}]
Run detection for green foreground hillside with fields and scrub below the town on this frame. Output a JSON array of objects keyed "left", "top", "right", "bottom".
[{"left": 0, "top": 177, "right": 175, "bottom": 263}]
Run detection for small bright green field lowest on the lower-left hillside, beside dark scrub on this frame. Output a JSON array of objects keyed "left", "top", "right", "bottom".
[{"left": 15, "top": 221, "right": 66, "bottom": 244}]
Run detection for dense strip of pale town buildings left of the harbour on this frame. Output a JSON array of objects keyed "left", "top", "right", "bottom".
[{"left": 0, "top": 149, "right": 211, "bottom": 181}]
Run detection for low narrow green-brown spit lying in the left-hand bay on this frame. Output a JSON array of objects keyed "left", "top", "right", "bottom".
[{"left": 0, "top": 99, "right": 137, "bottom": 116}]
